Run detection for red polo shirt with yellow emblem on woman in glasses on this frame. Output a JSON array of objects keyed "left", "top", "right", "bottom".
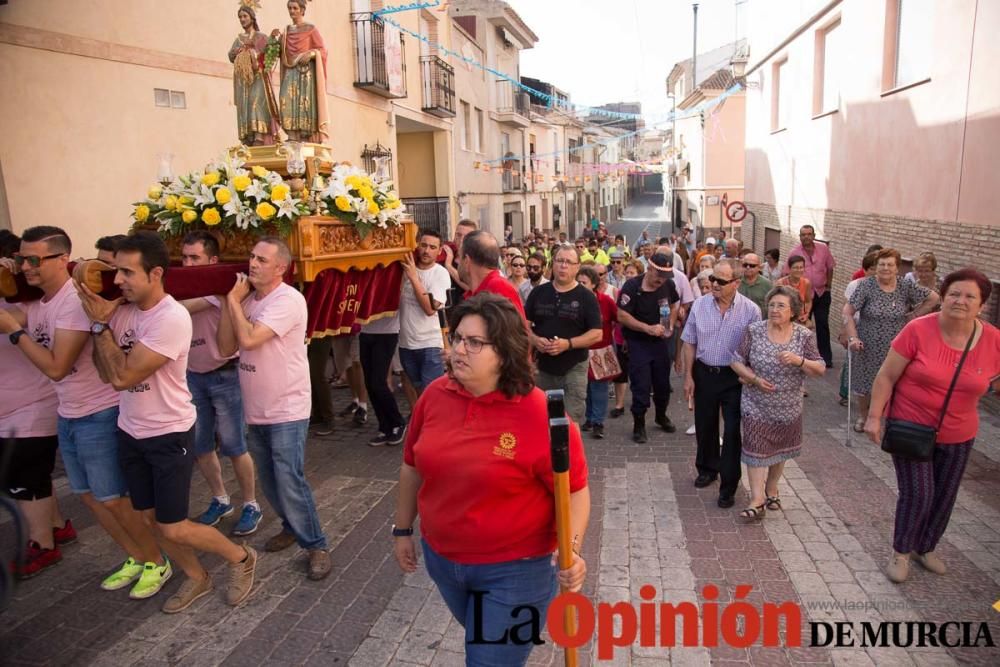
[{"left": 403, "top": 376, "right": 587, "bottom": 565}]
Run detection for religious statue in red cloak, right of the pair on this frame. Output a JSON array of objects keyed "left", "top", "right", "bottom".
[{"left": 271, "top": 0, "right": 330, "bottom": 143}]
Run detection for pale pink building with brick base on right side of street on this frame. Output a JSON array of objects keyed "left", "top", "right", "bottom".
[{"left": 744, "top": 0, "right": 1000, "bottom": 325}]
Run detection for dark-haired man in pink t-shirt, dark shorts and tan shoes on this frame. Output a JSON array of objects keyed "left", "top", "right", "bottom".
[{"left": 76, "top": 232, "right": 257, "bottom": 613}]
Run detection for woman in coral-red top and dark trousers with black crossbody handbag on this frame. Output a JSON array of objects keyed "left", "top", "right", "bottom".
[{"left": 865, "top": 269, "right": 1000, "bottom": 583}]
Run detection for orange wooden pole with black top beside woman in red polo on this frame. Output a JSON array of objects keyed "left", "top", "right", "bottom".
[{"left": 545, "top": 389, "right": 577, "bottom": 667}]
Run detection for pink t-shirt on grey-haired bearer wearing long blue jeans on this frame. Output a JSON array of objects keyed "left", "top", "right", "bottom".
[{"left": 240, "top": 283, "right": 312, "bottom": 424}]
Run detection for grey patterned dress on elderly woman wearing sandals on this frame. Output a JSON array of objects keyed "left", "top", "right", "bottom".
[{"left": 733, "top": 321, "right": 823, "bottom": 467}]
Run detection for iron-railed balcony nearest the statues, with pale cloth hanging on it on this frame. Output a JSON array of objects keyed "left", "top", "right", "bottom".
[{"left": 351, "top": 12, "right": 406, "bottom": 98}]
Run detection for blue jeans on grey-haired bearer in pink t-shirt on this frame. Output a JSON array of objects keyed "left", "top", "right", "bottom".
[{"left": 247, "top": 419, "right": 326, "bottom": 549}]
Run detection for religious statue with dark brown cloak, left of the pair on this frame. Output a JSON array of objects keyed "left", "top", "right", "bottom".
[{"left": 229, "top": 5, "right": 278, "bottom": 146}]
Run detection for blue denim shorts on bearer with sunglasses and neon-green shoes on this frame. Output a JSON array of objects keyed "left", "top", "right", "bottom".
[{"left": 58, "top": 405, "right": 128, "bottom": 502}]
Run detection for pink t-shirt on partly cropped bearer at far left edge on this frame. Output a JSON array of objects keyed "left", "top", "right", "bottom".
[{"left": 0, "top": 300, "right": 59, "bottom": 438}]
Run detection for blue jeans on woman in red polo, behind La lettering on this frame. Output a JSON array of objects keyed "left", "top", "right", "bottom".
[{"left": 423, "top": 542, "right": 557, "bottom": 667}]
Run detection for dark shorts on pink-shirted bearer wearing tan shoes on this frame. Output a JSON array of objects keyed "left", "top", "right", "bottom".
[{"left": 118, "top": 427, "right": 195, "bottom": 523}]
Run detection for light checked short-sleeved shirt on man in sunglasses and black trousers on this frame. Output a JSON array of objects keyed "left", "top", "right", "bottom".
[{"left": 681, "top": 292, "right": 761, "bottom": 366}]
